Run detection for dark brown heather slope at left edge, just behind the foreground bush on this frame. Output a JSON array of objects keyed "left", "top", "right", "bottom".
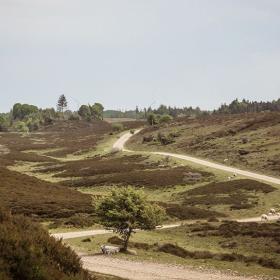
[{"left": 0, "top": 167, "right": 94, "bottom": 218}]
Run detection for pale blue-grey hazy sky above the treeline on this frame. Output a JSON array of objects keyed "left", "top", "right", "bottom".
[{"left": 0, "top": 0, "right": 280, "bottom": 111}]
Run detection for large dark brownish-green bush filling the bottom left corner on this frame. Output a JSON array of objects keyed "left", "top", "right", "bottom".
[{"left": 0, "top": 209, "right": 92, "bottom": 280}]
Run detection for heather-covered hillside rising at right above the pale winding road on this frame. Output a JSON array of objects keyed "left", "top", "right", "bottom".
[{"left": 129, "top": 112, "right": 280, "bottom": 176}]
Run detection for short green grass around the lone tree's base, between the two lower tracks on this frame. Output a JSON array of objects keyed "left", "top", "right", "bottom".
[{"left": 67, "top": 223, "right": 280, "bottom": 277}]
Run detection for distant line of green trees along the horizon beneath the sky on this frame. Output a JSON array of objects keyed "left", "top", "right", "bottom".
[{"left": 0, "top": 94, "right": 280, "bottom": 132}]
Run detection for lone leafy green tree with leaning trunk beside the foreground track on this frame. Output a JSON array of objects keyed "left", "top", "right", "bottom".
[{"left": 97, "top": 187, "right": 165, "bottom": 251}]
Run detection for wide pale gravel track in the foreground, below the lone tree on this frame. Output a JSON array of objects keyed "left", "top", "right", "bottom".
[{"left": 82, "top": 256, "right": 257, "bottom": 280}]
